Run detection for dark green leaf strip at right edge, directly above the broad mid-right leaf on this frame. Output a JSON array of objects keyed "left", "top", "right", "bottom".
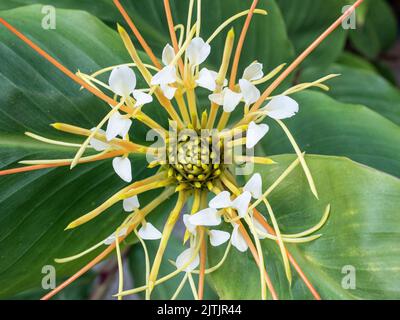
[{"left": 299, "top": 64, "right": 400, "bottom": 124}]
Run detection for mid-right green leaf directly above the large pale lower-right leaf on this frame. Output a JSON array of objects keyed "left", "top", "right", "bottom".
[{"left": 260, "top": 91, "right": 400, "bottom": 176}]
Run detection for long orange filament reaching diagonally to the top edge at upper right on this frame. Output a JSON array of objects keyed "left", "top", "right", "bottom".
[{"left": 251, "top": 0, "right": 364, "bottom": 111}]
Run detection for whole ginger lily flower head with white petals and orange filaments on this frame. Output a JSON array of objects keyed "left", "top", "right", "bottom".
[{"left": 0, "top": 0, "right": 362, "bottom": 299}]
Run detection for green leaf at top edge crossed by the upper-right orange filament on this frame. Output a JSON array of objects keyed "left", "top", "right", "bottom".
[{"left": 277, "top": 0, "right": 347, "bottom": 66}]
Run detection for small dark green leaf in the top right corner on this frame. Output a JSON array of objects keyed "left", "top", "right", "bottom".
[{"left": 349, "top": 0, "right": 397, "bottom": 59}]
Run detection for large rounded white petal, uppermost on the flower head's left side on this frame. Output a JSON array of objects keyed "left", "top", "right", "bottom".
[{"left": 108, "top": 66, "right": 136, "bottom": 97}]
